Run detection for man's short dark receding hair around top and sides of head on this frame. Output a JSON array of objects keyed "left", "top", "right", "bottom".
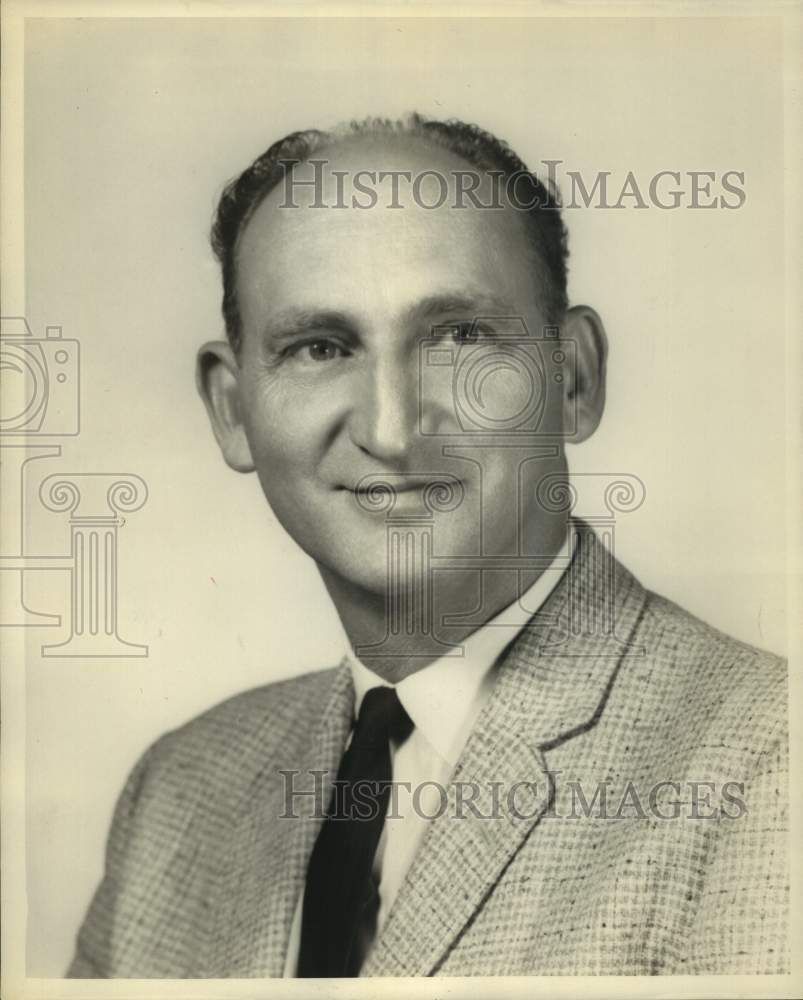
[{"left": 211, "top": 114, "right": 569, "bottom": 350}]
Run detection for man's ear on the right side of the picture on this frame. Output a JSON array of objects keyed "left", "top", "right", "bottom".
[{"left": 561, "top": 306, "right": 608, "bottom": 444}]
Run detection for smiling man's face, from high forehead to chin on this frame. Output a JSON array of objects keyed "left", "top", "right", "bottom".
[{"left": 220, "top": 140, "right": 563, "bottom": 593}]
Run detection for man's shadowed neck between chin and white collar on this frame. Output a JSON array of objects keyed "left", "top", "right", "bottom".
[{"left": 318, "top": 518, "right": 566, "bottom": 684}]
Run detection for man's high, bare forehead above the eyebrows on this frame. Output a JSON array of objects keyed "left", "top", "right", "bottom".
[{"left": 237, "top": 136, "right": 536, "bottom": 329}]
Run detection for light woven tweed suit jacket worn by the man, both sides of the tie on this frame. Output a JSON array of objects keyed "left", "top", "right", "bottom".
[{"left": 68, "top": 532, "right": 788, "bottom": 978}]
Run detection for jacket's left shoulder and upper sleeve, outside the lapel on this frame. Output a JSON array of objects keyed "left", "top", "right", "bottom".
[{"left": 68, "top": 669, "right": 346, "bottom": 978}]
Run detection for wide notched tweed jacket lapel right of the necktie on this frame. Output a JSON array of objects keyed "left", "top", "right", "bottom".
[{"left": 361, "top": 521, "right": 646, "bottom": 976}]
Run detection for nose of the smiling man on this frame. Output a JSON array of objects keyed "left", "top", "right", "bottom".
[{"left": 349, "top": 356, "right": 418, "bottom": 464}]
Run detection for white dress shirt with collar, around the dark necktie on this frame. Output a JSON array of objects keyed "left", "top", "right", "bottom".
[{"left": 283, "top": 543, "right": 566, "bottom": 978}]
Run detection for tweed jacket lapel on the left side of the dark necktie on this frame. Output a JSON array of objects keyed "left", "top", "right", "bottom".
[{"left": 207, "top": 661, "right": 354, "bottom": 977}]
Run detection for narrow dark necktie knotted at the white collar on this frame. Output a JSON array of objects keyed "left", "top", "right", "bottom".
[{"left": 298, "top": 687, "right": 413, "bottom": 978}]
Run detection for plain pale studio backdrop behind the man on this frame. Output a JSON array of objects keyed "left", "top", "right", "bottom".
[{"left": 25, "top": 18, "right": 785, "bottom": 976}]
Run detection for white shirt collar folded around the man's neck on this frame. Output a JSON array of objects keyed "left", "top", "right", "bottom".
[{"left": 346, "top": 540, "right": 569, "bottom": 767}]
